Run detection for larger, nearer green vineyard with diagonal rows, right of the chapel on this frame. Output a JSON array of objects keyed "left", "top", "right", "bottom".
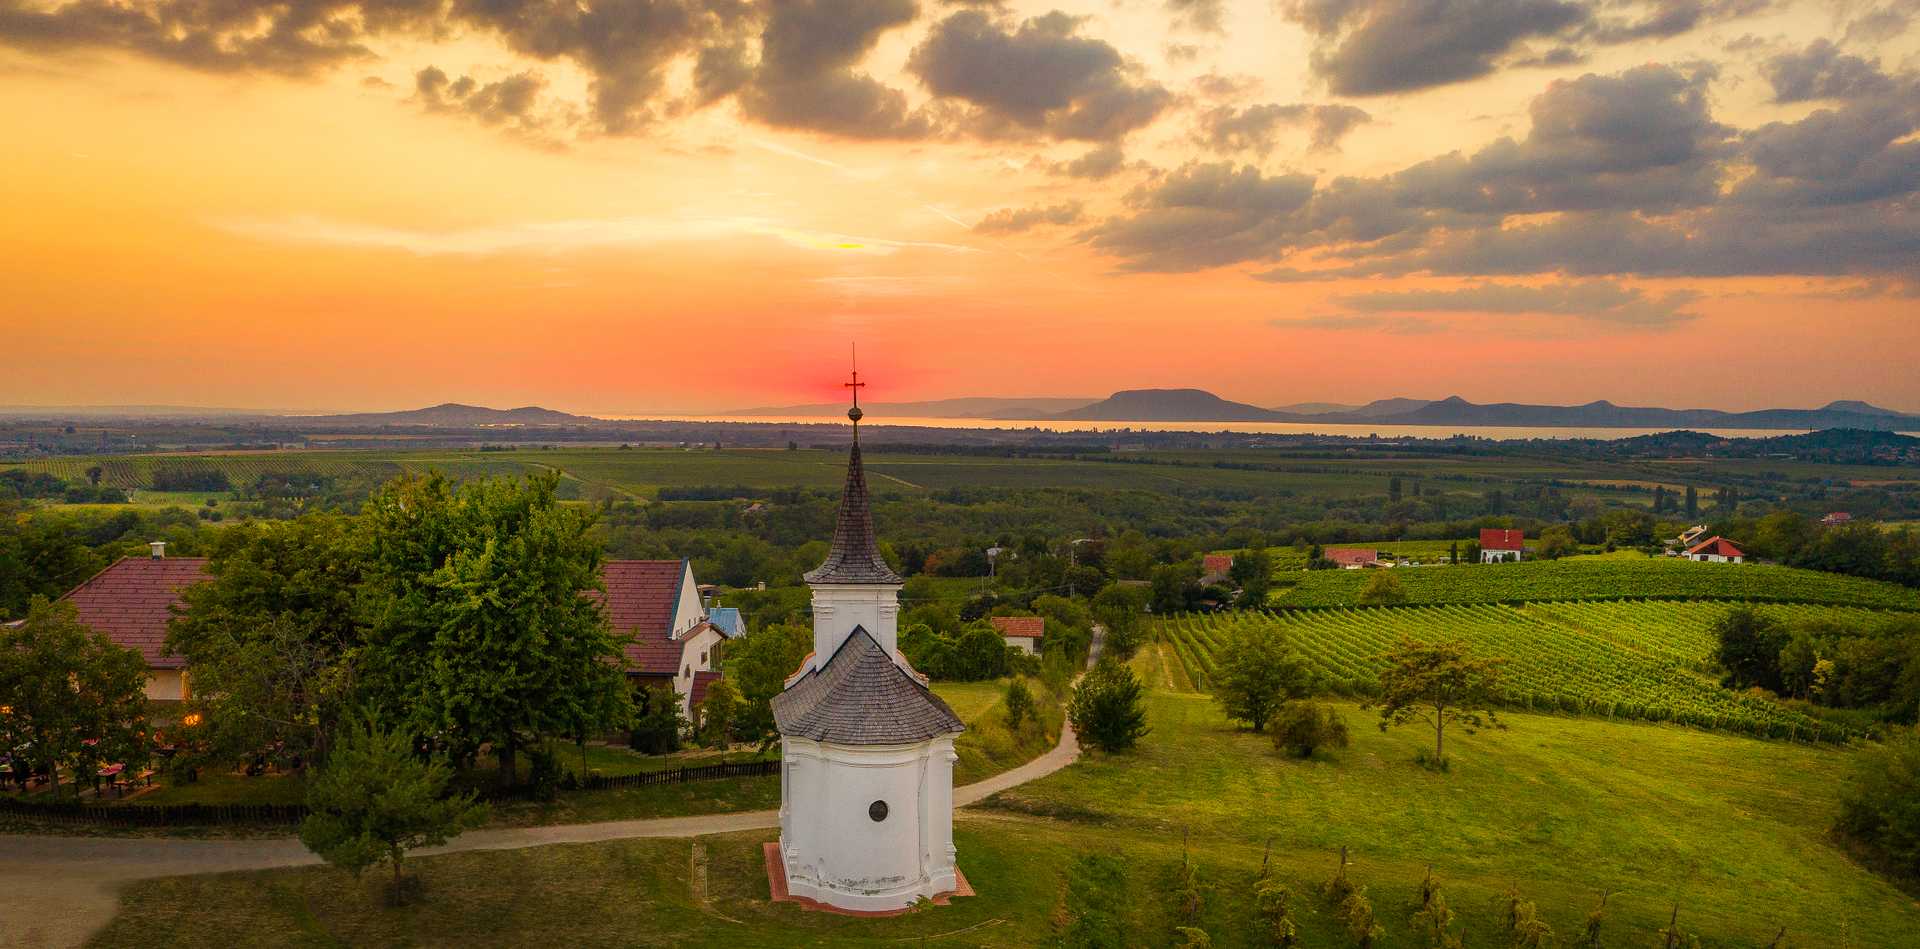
[{"left": 1158, "top": 601, "right": 1904, "bottom": 742}]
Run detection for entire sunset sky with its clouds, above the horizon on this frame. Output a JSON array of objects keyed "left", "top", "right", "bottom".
[{"left": 0, "top": 0, "right": 1920, "bottom": 413}]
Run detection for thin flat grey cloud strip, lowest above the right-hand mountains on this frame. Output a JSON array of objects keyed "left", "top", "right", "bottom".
[{"left": 1336, "top": 280, "right": 1699, "bottom": 329}]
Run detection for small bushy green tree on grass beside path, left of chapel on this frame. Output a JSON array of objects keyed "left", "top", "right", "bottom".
[{"left": 300, "top": 718, "right": 488, "bottom": 903}]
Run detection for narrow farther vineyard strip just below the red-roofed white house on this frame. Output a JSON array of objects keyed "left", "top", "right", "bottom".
[{"left": 1273, "top": 557, "right": 1920, "bottom": 609}]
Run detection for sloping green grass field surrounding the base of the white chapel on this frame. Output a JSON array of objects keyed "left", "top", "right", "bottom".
[{"left": 94, "top": 694, "right": 1920, "bottom": 949}]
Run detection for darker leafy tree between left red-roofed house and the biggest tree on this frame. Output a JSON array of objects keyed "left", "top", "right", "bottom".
[{"left": 167, "top": 515, "right": 365, "bottom": 761}]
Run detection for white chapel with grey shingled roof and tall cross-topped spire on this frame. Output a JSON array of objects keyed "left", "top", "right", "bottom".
[{"left": 774, "top": 386, "right": 964, "bottom": 913}]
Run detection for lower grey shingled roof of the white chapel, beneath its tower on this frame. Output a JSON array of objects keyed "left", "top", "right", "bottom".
[{"left": 774, "top": 626, "right": 966, "bottom": 745}]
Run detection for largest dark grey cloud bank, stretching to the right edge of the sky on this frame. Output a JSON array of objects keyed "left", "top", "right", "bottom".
[{"left": 1083, "top": 65, "right": 1920, "bottom": 290}]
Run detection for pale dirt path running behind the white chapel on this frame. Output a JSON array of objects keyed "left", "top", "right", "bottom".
[{"left": 0, "top": 722, "right": 1079, "bottom": 949}]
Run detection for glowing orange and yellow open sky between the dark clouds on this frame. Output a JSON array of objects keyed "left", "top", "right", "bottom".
[{"left": 0, "top": 0, "right": 1920, "bottom": 413}]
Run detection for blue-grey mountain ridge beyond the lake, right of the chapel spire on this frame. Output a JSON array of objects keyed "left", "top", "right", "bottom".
[{"left": 1052, "top": 388, "right": 1920, "bottom": 432}]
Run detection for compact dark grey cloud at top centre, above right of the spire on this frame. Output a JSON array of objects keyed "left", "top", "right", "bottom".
[{"left": 908, "top": 10, "right": 1173, "bottom": 140}]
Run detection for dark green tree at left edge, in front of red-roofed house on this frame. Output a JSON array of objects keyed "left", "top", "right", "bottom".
[{"left": 0, "top": 597, "right": 148, "bottom": 793}]
